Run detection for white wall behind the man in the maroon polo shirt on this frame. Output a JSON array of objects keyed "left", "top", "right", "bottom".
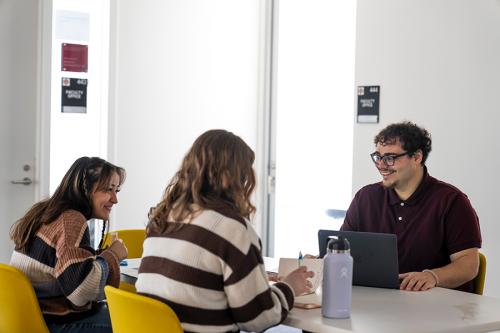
[{"left": 353, "top": 0, "right": 500, "bottom": 297}]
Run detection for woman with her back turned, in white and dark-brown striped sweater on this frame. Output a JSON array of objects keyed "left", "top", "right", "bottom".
[{"left": 136, "top": 130, "right": 313, "bottom": 332}]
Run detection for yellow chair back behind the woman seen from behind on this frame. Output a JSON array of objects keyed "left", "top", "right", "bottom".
[{"left": 104, "top": 286, "right": 183, "bottom": 333}]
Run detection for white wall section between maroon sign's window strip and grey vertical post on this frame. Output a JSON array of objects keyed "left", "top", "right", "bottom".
[{"left": 109, "top": 0, "right": 261, "bottom": 228}]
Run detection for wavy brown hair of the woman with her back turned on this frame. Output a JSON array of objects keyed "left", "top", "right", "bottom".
[{"left": 147, "top": 130, "right": 255, "bottom": 234}]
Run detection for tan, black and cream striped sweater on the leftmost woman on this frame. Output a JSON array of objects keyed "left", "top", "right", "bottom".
[{"left": 10, "top": 210, "right": 120, "bottom": 319}]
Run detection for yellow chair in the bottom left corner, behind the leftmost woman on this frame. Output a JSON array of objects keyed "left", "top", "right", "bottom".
[{"left": 0, "top": 264, "right": 50, "bottom": 333}]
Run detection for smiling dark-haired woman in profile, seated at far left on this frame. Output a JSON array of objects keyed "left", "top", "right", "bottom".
[{"left": 10, "top": 157, "right": 127, "bottom": 333}]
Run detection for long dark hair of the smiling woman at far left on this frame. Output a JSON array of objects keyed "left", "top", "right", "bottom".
[{"left": 10, "top": 157, "right": 125, "bottom": 250}]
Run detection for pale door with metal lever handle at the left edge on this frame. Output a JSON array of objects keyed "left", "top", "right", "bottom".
[{"left": 0, "top": 0, "right": 39, "bottom": 263}]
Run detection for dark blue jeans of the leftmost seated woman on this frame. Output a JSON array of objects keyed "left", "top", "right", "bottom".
[{"left": 47, "top": 302, "right": 113, "bottom": 333}]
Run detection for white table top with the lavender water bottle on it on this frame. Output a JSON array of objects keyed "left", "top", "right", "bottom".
[{"left": 121, "top": 259, "right": 500, "bottom": 333}]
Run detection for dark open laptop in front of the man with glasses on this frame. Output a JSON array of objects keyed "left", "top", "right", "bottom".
[{"left": 318, "top": 230, "right": 399, "bottom": 289}]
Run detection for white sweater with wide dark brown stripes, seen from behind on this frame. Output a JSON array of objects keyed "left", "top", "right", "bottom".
[{"left": 136, "top": 210, "right": 294, "bottom": 332}]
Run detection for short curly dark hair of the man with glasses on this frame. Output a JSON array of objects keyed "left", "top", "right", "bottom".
[{"left": 373, "top": 121, "right": 432, "bottom": 165}]
